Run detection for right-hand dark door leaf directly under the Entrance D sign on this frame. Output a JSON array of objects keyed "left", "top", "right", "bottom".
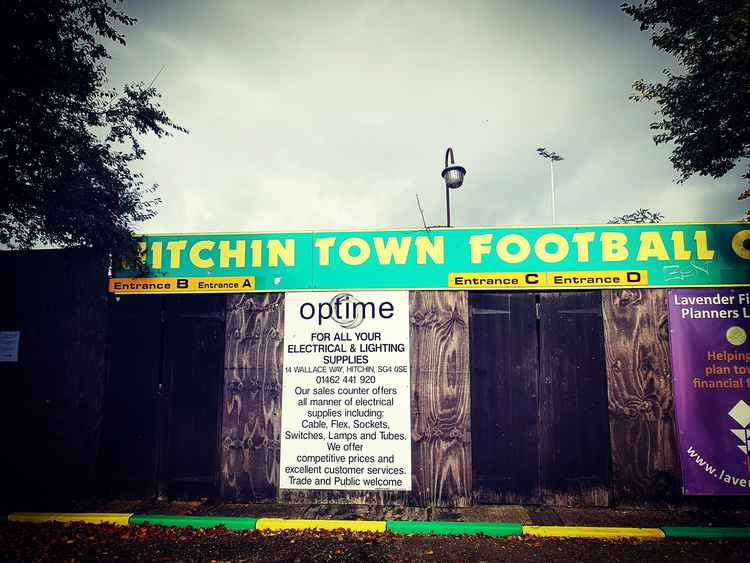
[{"left": 539, "top": 291, "right": 610, "bottom": 505}]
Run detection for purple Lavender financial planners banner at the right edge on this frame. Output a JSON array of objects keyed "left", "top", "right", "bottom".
[{"left": 668, "top": 288, "right": 750, "bottom": 495}]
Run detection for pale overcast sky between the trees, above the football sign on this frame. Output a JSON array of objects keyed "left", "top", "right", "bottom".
[{"left": 110, "top": 0, "right": 744, "bottom": 232}]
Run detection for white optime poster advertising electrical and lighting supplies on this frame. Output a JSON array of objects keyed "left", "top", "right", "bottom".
[{"left": 280, "top": 291, "right": 411, "bottom": 491}]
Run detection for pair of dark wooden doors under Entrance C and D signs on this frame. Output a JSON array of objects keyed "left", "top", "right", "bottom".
[{"left": 470, "top": 291, "right": 611, "bottom": 506}]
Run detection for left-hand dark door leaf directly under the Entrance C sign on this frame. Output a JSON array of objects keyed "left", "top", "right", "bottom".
[{"left": 469, "top": 292, "right": 540, "bottom": 504}]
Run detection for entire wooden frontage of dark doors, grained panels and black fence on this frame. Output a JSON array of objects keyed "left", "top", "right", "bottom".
[{"left": 0, "top": 250, "right": 692, "bottom": 509}]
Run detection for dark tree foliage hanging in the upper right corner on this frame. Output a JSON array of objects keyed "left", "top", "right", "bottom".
[{"left": 621, "top": 0, "right": 750, "bottom": 217}]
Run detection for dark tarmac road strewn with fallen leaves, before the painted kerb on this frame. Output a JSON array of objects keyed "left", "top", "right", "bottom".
[{"left": 0, "top": 522, "right": 750, "bottom": 563}]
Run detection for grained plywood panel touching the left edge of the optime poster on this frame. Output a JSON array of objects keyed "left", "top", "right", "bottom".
[{"left": 220, "top": 293, "right": 284, "bottom": 502}]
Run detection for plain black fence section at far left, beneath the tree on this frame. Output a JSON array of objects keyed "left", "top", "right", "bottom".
[{"left": 0, "top": 250, "right": 107, "bottom": 509}]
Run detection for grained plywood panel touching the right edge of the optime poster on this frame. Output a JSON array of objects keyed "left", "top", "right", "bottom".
[{"left": 409, "top": 291, "right": 472, "bottom": 506}]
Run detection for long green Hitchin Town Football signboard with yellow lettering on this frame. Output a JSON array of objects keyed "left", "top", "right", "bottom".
[{"left": 110, "top": 223, "right": 750, "bottom": 293}]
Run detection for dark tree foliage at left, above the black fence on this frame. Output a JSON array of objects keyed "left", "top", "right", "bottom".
[{"left": 0, "top": 0, "right": 185, "bottom": 255}]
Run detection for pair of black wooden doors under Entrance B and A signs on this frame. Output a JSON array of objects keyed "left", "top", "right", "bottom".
[{"left": 98, "top": 295, "right": 226, "bottom": 498}]
